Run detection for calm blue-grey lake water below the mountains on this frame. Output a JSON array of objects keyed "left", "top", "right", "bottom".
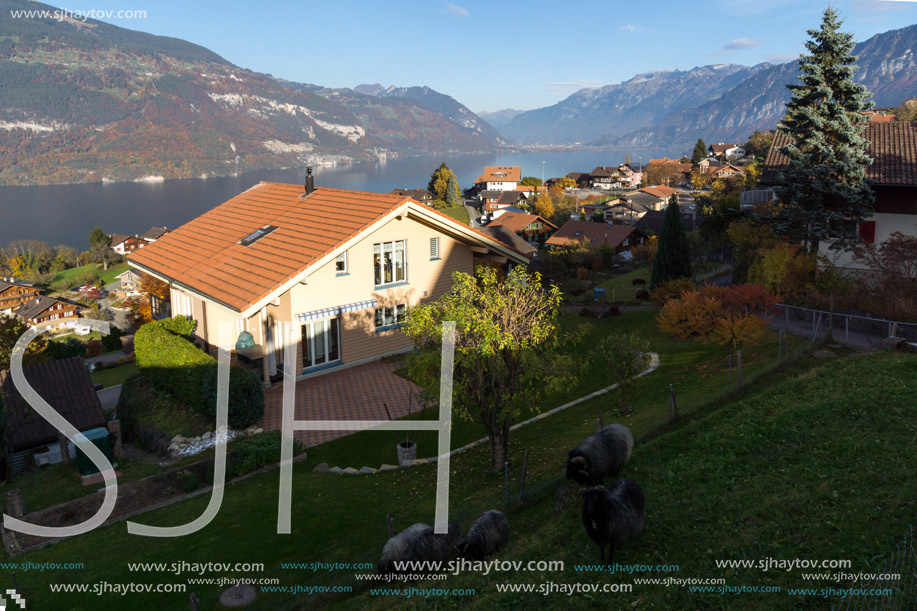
[{"left": 0, "top": 151, "right": 662, "bottom": 250}]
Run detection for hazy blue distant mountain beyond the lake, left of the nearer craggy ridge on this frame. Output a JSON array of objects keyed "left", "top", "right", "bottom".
[{"left": 500, "top": 64, "right": 771, "bottom": 144}]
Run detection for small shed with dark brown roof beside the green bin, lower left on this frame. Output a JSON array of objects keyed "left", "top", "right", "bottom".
[{"left": 0, "top": 357, "right": 107, "bottom": 475}]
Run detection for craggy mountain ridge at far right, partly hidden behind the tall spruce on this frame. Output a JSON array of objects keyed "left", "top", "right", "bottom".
[{"left": 608, "top": 25, "right": 917, "bottom": 150}]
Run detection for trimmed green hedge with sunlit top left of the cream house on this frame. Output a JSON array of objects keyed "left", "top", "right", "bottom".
[{"left": 134, "top": 316, "right": 264, "bottom": 428}]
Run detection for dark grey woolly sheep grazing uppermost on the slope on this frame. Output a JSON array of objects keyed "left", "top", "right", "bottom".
[{"left": 567, "top": 424, "right": 634, "bottom": 485}]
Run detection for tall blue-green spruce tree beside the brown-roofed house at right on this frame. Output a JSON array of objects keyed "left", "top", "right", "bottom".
[{"left": 776, "top": 8, "right": 874, "bottom": 252}]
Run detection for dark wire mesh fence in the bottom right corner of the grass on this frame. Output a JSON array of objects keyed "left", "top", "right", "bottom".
[{"left": 831, "top": 526, "right": 917, "bottom": 611}]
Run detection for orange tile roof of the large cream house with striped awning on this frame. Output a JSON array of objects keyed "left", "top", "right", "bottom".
[{"left": 130, "top": 182, "right": 524, "bottom": 312}]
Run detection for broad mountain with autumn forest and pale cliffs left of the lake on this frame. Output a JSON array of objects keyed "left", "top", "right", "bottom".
[{"left": 0, "top": 0, "right": 502, "bottom": 184}]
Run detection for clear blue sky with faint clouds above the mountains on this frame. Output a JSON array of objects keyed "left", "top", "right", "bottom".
[{"left": 57, "top": 0, "right": 917, "bottom": 112}]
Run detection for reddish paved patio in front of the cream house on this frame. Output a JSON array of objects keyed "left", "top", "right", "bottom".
[{"left": 261, "top": 361, "right": 420, "bottom": 448}]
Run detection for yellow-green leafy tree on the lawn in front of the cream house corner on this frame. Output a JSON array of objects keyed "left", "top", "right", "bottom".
[{"left": 403, "top": 266, "right": 575, "bottom": 471}]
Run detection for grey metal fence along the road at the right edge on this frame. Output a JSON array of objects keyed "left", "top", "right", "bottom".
[{"left": 772, "top": 304, "right": 917, "bottom": 344}]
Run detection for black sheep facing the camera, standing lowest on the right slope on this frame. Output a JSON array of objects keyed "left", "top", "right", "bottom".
[{"left": 583, "top": 477, "right": 646, "bottom": 563}]
